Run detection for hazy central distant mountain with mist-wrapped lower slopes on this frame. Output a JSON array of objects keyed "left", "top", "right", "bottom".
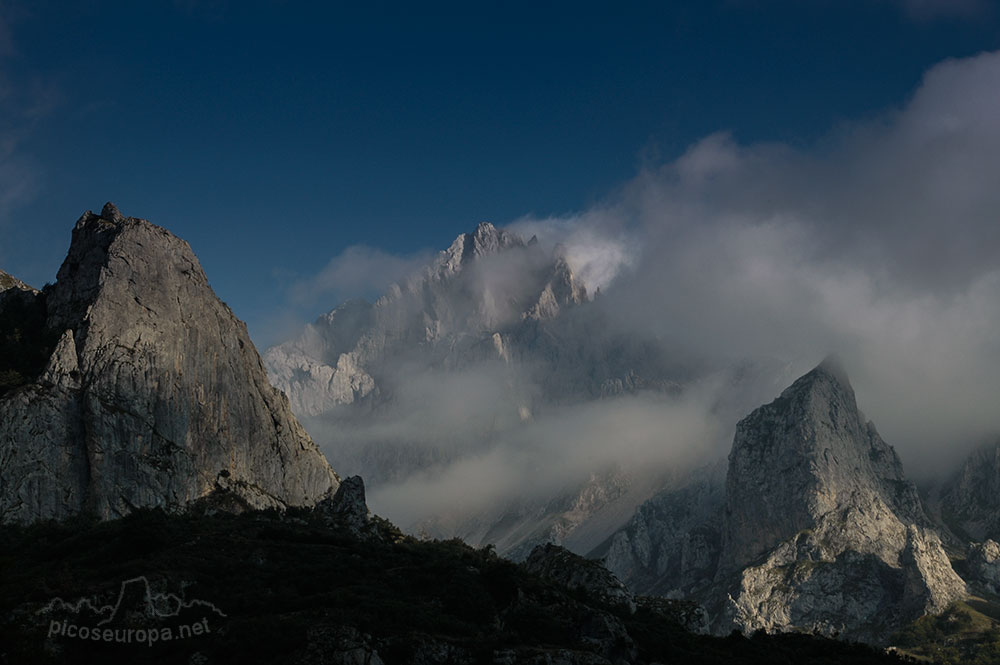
[{"left": 264, "top": 223, "right": 796, "bottom": 558}]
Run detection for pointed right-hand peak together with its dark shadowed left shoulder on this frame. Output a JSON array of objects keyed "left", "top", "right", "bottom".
[{"left": 592, "top": 359, "right": 966, "bottom": 642}]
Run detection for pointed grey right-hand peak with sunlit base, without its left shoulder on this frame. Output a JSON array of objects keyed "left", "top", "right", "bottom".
[{"left": 716, "top": 360, "right": 966, "bottom": 641}]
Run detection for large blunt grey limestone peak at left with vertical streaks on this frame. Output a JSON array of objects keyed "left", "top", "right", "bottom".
[{"left": 0, "top": 204, "right": 338, "bottom": 522}]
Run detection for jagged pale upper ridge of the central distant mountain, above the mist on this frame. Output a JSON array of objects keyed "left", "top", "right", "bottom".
[{"left": 265, "top": 222, "right": 587, "bottom": 416}]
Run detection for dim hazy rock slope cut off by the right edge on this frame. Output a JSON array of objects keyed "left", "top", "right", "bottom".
[{"left": 941, "top": 441, "right": 1000, "bottom": 541}]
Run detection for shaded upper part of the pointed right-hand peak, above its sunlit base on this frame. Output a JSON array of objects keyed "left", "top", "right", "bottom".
[{"left": 723, "top": 359, "right": 923, "bottom": 566}]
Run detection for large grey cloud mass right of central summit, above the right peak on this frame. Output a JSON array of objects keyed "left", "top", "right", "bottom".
[{"left": 516, "top": 53, "right": 1000, "bottom": 475}]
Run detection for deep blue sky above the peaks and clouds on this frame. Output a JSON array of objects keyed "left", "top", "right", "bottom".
[{"left": 0, "top": 0, "right": 1000, "bottom": 344}]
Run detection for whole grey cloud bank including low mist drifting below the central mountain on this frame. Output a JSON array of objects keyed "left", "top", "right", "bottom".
[{"left": 298, "top": 53, "right": 1000, "bottom": 537}]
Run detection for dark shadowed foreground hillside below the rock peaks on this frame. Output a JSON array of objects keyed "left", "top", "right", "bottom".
[{"left": 0, "top": 510, "right": 900, "bottom": 665}]
